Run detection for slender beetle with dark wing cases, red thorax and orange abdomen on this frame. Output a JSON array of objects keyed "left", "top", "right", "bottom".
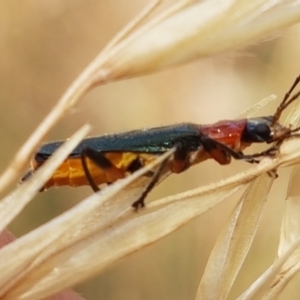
[{"left": 21, "top": 75, "right": 300, "bottom": 210}]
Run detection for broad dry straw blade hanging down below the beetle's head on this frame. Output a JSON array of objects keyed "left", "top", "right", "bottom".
[{"left": 197, "top": 174, "right": 272, "bottom": 299}]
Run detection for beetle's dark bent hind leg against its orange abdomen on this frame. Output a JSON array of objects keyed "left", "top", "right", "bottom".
[{"left": 81, "top": 148, "right": 124, "bottom": 192}]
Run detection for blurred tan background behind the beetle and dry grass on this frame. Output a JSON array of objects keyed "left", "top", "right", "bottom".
[{"left": 0, "top": 0, "right": 300, "bottom": 300}]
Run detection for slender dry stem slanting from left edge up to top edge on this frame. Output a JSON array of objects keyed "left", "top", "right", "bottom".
[{"left": 0, "top": 1, "right": 169, "bottom": 193}]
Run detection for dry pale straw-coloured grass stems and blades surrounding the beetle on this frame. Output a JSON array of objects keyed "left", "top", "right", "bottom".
[{"left": 0, "top": 0, "right": 300, "bottom": 299}]
